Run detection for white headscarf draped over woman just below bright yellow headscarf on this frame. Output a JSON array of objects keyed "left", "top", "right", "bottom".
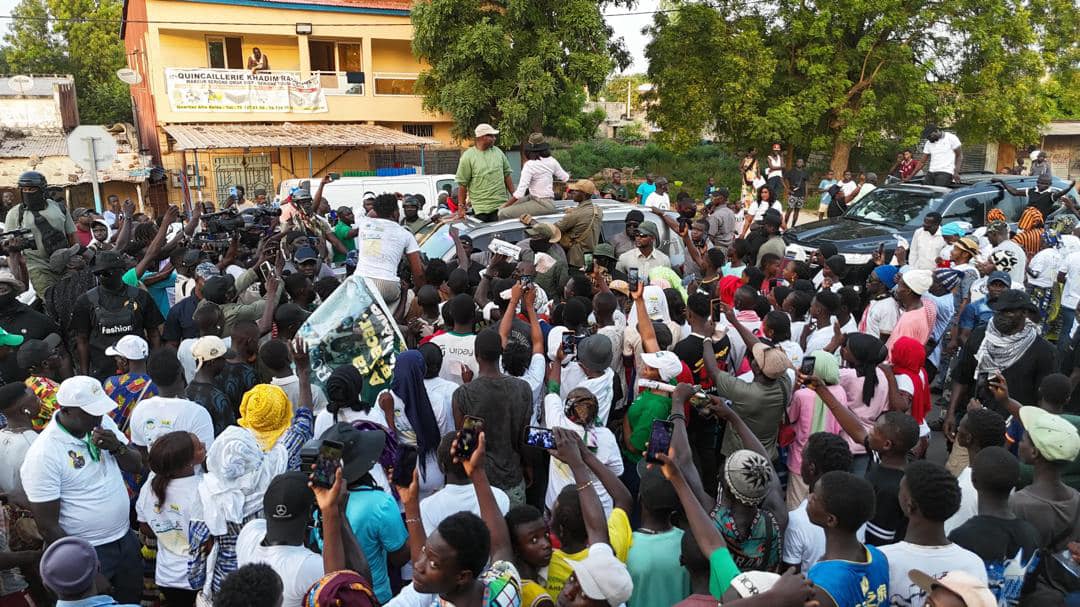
[{"left": 195, "top": 426, "right": 288, "bottom": 536}]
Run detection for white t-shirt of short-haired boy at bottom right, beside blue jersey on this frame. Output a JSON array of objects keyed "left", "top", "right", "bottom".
[{"left": 880, "top": 541, "right": 986, "bottom": 607}]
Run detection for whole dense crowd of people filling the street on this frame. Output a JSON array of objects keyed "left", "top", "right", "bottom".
[{"left": 0, "top": 119, "right": 1080, "bottom": 607}]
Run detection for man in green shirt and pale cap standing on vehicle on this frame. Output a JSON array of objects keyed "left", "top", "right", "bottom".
[{"left": 455, "top": 123, "right": 514, "bottom": 221}]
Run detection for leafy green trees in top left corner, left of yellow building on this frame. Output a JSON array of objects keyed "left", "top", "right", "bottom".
[{"left": 3, "top": 0, "right": 132, "bottom": 124}]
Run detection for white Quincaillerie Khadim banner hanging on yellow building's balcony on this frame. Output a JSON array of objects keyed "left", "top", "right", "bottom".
[{"left": 165, "top": 68, "right": 326, "bottom": 113}]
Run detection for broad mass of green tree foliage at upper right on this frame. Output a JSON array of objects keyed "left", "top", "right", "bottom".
[{"left": 646, "top": 0, "right": 1062, "bottom": 163}]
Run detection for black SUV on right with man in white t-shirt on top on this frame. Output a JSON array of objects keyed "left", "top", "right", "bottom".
[{"left": 784, "top": 173, "right": 1080, "bottom": 265}]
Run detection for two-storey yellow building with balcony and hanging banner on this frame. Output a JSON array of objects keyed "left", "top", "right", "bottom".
[{"left": 121, "top": 0, "right": 460, "bottom": 206}]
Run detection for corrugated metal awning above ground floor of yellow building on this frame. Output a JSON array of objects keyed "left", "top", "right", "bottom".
[{"left": 164, "top": 122, "right": 438, "bottom": 150}]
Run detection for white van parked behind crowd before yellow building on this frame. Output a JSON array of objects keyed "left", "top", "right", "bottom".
[{"left": 279, "top": 175, "right": 457, "bottom": 217}]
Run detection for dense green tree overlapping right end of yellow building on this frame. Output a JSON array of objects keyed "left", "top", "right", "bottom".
[{"left": 411, "top": 0, "right": 630, "bottom": 141}]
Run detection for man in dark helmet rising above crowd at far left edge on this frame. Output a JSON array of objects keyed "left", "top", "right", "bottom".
[{"left": 0, "top": 171, "right": 76, "bottom": 294}]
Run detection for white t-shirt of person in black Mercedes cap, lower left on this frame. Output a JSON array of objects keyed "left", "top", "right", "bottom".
[{"left": 237, "top": 518, "right": 323, "bottom": 605}]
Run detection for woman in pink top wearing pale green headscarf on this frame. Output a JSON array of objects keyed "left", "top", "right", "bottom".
[{"left": 787, "top": 350, "right": 846, "bottom": 510}]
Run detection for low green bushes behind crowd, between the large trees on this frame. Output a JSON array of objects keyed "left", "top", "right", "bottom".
[{"left": 554, "top": 139, "right": 739, "bottom": 194}]
